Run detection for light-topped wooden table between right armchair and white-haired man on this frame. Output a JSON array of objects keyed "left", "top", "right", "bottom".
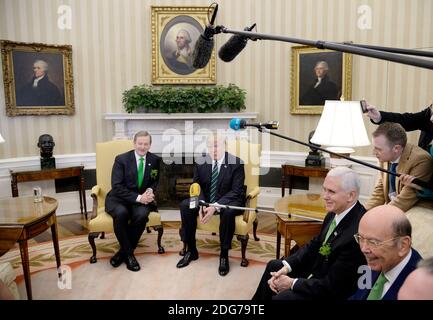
[{"left": 275, "top": 194, "right": 327, "bottom": 259}]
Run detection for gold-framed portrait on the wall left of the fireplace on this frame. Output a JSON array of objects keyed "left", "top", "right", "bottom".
[{"left": 0, "top": 40, "right": 75, "bottom": 117}]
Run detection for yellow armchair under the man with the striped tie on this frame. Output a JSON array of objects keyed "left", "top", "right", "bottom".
[{"left": 181, "top": 140, "right": 261, "bottom": 267}]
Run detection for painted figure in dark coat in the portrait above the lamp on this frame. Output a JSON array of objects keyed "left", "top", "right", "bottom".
[{"left": 299, "top": 61, "right": 340, "bottom": 106}]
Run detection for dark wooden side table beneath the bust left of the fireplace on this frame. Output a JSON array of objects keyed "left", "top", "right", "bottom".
[{"left": 10, "top": 166, "right": 87, "bottom": 220}]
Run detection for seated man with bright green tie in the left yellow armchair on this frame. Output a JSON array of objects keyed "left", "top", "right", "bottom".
[{"left": 105, "top": 131, "right": 161, "bottom": 271}]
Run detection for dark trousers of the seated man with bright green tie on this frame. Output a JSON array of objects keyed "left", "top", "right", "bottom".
[{"left": 109, "top": 203, "right": 151, "bottom": 255}]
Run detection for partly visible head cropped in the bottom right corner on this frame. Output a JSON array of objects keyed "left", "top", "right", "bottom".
[{"left": 398, "top": 257, "right": 433, "bottom": 300}]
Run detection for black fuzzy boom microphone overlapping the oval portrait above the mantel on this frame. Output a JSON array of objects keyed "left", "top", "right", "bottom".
[{"left": 192, "top": 4, "right": 218, "bottom": 69}]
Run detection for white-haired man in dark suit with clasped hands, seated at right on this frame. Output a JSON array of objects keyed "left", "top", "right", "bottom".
[{"left": 253, "top": 167, "right": 365, "bottom": 300}]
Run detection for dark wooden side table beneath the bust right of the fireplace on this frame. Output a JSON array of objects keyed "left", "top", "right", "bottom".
[{"left": 281, "top": 163, "right": 331, "bottom": 197}]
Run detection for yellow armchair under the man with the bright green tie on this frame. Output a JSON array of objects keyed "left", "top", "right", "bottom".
[{"left": 89, "top": 140, "right": 164, "bottom": 263}]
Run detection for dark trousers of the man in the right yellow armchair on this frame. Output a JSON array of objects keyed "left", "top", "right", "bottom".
[{"left": 180, "top": 199, "right": 242, "bottom": 251}]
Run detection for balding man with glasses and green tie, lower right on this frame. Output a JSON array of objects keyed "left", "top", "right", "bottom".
[{"left": 351, "top": 205, "right": 421, "bottom": 300}]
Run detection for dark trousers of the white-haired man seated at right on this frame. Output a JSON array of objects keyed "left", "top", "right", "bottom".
[{"left": 252, "top": 259, "right": 309, "bottom": 300}]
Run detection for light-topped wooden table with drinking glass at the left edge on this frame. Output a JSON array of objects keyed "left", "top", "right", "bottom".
[{"left": 0, "top": 196, "right": 60, "bottom": 300}]
